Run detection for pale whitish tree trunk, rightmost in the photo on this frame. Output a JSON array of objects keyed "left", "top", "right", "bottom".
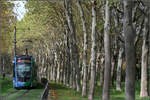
[{"left": 140, "top": 7, "right": 149, "bottom": 97}]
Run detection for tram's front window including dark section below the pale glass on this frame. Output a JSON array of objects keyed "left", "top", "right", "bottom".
[{"left": 16, "top": 63, "right": 31, "bottom": 82}]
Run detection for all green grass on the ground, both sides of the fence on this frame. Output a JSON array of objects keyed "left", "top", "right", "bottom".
[{"left": 0, "top": 77, "right": 150, "bottom": 100}]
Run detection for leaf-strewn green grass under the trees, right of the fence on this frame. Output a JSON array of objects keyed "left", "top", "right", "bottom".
[{"left": 50, "top": 82, "right": 150, "bottom": 100}]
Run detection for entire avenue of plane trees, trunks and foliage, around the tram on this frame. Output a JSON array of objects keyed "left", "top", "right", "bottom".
[{"left": 0, "top": 0, "right": 150, "bottom": 100}]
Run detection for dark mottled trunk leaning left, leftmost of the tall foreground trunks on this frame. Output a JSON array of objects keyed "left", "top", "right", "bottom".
[{"left": 65, "top": 0, "right": 80, "bottom": 92}]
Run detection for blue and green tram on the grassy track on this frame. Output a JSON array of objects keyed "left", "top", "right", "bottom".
[{"left": 13, "top": 55, "right": 36, "bottom": 89}]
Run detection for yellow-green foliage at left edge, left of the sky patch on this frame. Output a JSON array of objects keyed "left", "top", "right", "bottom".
[{"left": 0, "top": 1, "right": 16, "bottom": 53}]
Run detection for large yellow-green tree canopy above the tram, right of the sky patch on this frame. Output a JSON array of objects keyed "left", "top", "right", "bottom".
[{"left": 12, "top": 1, "right": 64, "bottom": 55}]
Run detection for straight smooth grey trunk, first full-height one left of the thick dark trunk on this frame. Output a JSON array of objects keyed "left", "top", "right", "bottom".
[{"left": 102, "top": 0, "right": 111, "bottom": 100}]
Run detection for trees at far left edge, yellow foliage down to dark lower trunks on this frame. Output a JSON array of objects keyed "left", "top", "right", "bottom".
[{"left": 0, "top": 1, "right": 16, "bottom": 75}]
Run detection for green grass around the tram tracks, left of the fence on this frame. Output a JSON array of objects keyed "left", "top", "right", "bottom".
[{"left": 0, "top": 77, "right": 44, "bottom": 100}]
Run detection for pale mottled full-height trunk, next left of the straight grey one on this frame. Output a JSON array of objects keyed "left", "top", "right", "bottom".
[{"left": 88, "top": 0, "right": 96, "bottom": 100}]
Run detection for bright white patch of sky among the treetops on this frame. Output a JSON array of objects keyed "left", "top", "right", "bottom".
[{"left": 13, "top": 1, "right": 27, "bottom": 21}]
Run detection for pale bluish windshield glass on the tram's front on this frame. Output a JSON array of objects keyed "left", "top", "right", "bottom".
[{"left": 16, "top": 63, "right": 31, "bottom": 77}]
